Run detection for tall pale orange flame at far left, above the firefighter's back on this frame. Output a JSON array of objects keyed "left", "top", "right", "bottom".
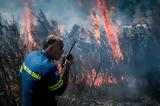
[{"left": 23, "top": 0, "right": 35, "bottom": 51}]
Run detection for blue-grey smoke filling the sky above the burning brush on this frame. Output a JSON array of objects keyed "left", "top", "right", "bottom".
[{"left": 0, "top": 0, "right": 158, "bottom": 31}]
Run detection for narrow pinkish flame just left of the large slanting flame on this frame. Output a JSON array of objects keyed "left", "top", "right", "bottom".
[{"left": 91, "top": 9, "right": 100, "bottom": 44}]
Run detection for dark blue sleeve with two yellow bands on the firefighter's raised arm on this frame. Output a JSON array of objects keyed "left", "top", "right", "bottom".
[{"left": 45, "top": 65, "right": 67, "bottom": 95}]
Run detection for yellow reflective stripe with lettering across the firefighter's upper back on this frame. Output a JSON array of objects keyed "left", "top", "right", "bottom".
[{"left": 20, "top": 63, "right": 41, "bottom": 80}]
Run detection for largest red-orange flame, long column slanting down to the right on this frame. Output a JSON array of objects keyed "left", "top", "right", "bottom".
[{"left": 97, "top": 0, "right": 123, "bottom": 60}]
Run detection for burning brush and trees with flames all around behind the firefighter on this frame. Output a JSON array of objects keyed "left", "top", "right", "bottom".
[{"left": 0, "top": 0, "right": 160, "bottom": 106}]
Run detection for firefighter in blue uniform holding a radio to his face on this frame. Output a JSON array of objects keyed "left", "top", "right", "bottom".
[{"left": 19, "top": 35, "right": 72, "bottom": 106}]
